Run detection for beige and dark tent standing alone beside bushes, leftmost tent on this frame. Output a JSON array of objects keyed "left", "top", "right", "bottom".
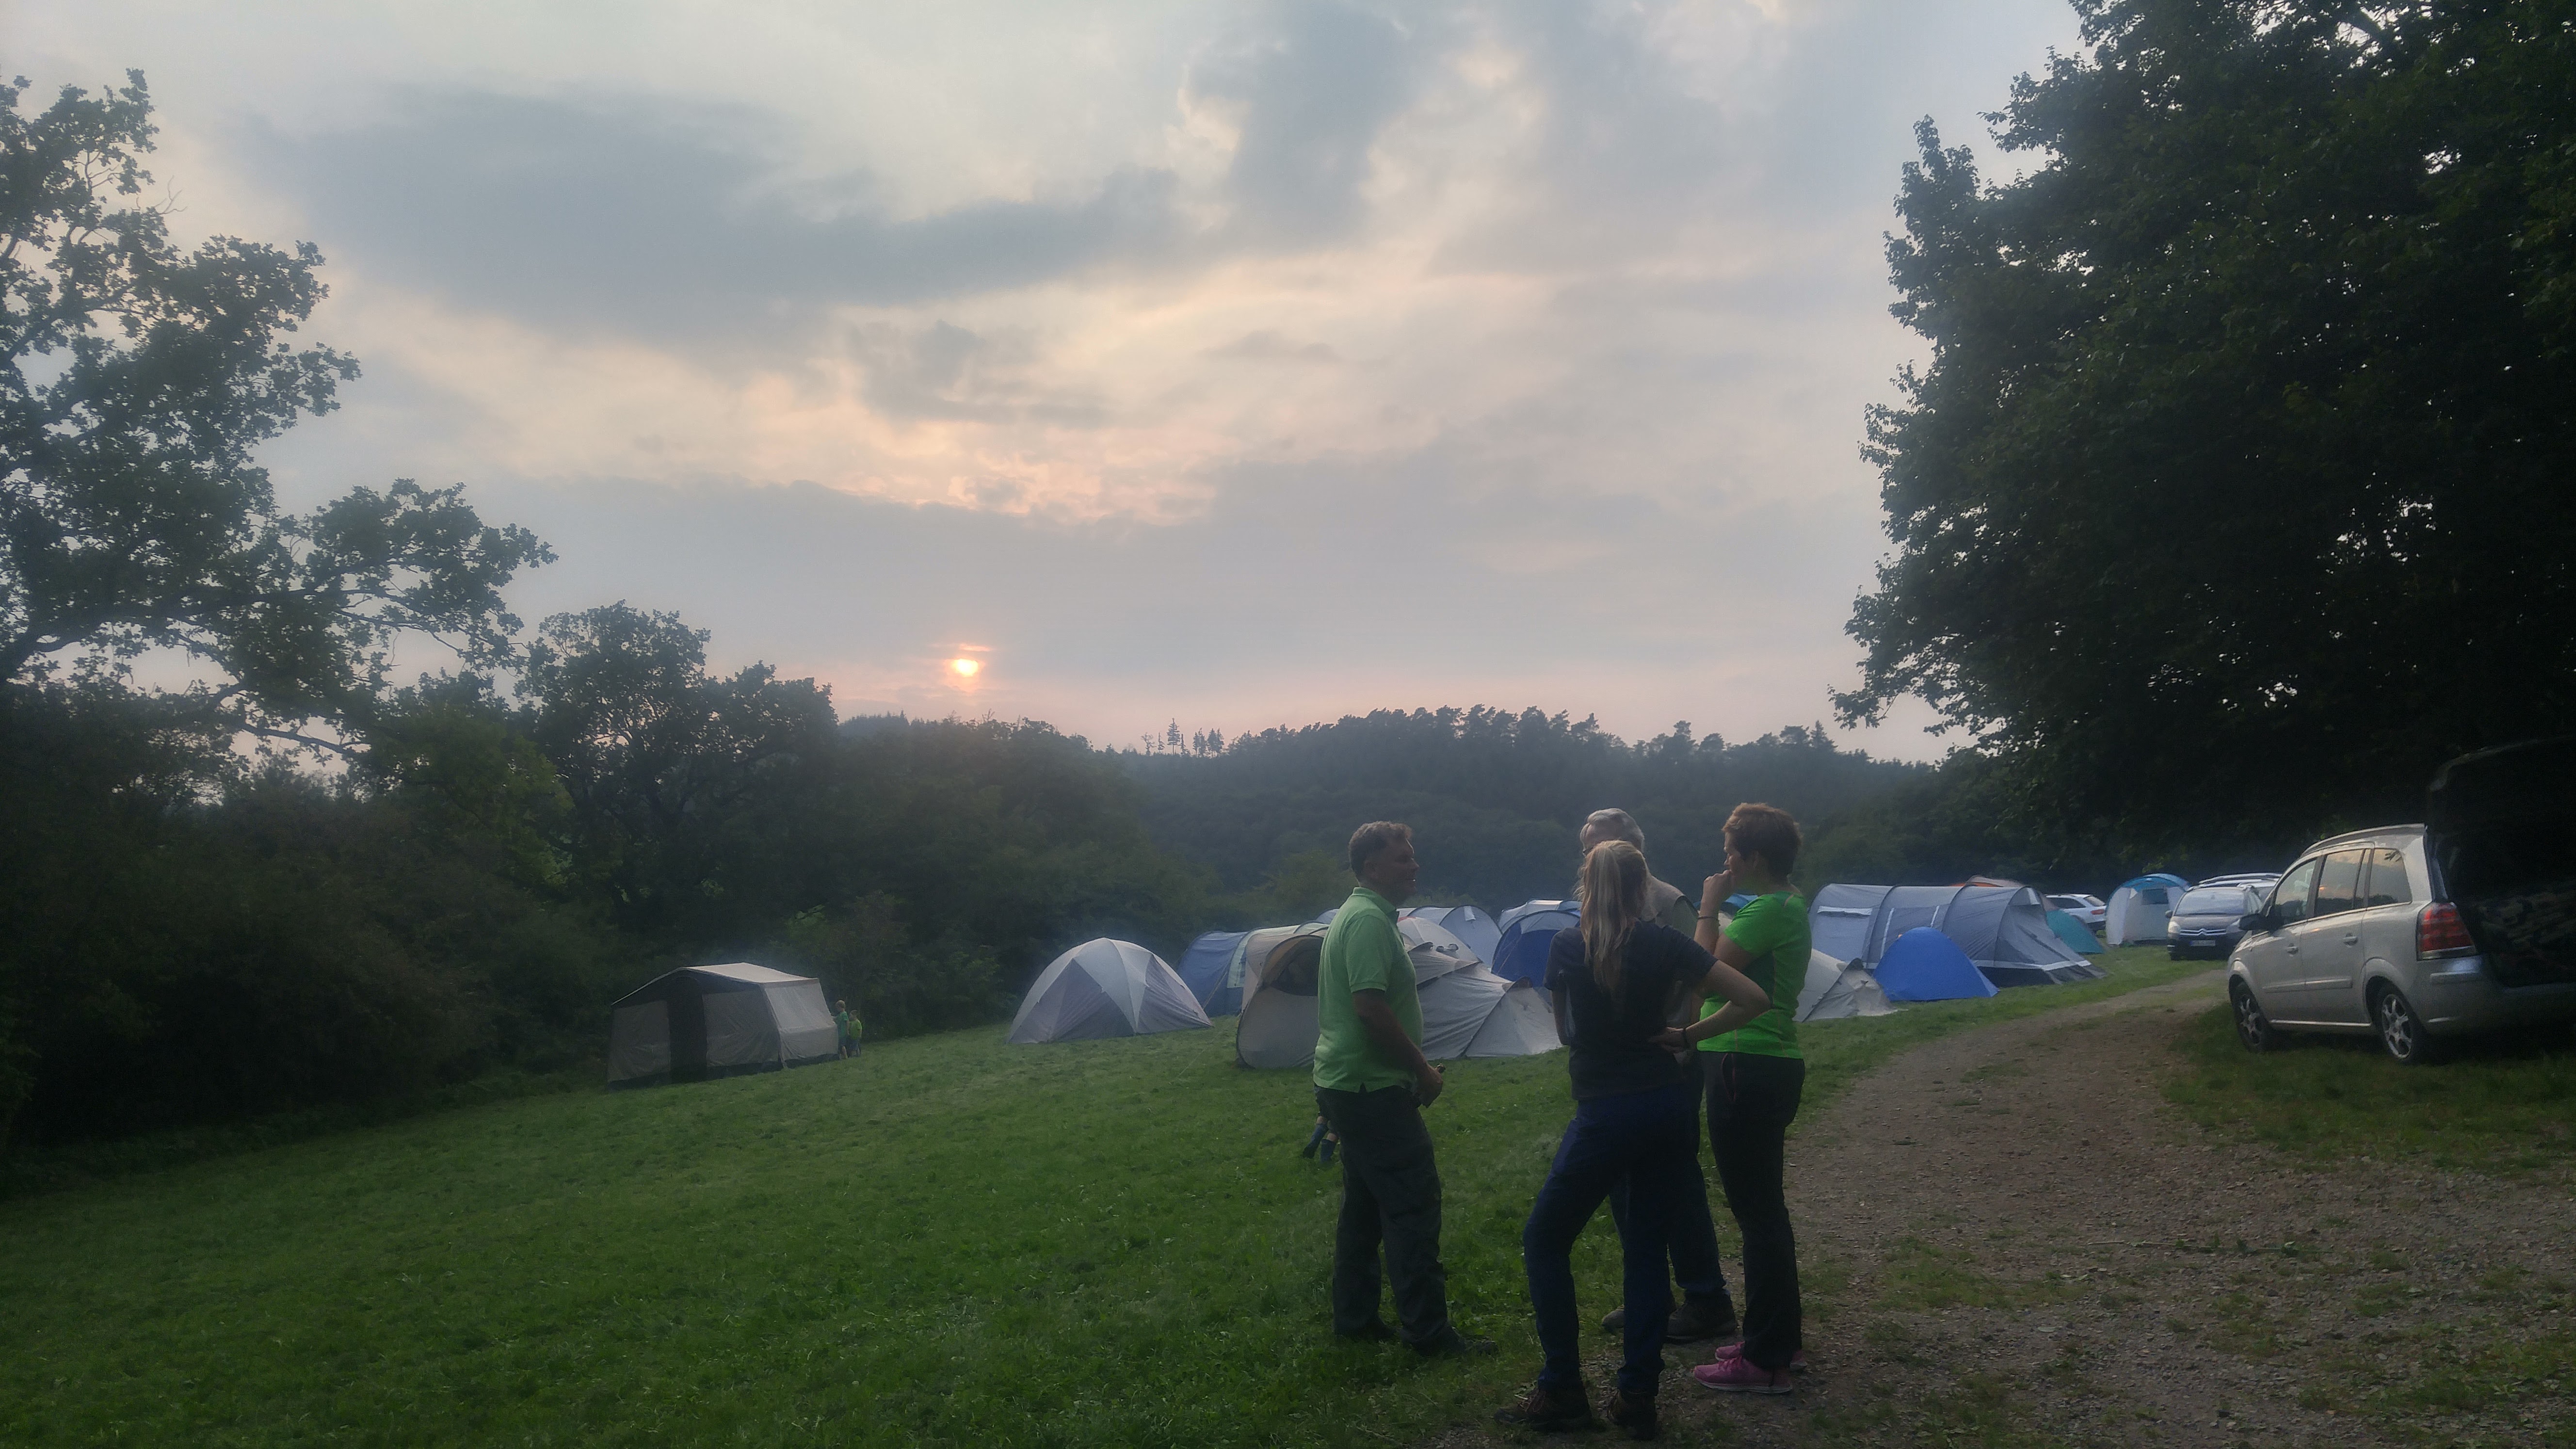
[{"left": 608, "top": 962, "right": 840, "bottom": 1085}]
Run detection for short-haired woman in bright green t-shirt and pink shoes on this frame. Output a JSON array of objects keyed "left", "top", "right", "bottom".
[{"left": 1679, "top": 805, "right": 1811, "bottom": 1395}]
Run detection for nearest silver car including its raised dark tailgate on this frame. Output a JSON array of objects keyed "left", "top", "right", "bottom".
[{"left": 2228, "top": 738, "right": 2576, "bottom": 1065}]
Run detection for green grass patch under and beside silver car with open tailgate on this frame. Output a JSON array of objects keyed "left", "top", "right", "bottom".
[{"left": 2164, "top": 1006, "right": 2576, "bottom": 1175}]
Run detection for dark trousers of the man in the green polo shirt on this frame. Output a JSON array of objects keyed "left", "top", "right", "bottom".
[{"left": 1314, "top": 1085, "right": 1448, "bottom": 1343}]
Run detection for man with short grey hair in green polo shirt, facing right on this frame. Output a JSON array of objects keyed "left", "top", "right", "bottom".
[{"left": 1314, "top": 820, "right": 1494, "bottom": 1356}]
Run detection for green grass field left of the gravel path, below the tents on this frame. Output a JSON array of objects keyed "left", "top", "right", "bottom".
[{"left": 0, "top": 949, "right": 2207, "bottom": 1447}]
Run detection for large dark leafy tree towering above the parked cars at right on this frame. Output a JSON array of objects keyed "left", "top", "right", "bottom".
[{"left": 1839, "top": 0, "right": 2576, "bottom": 843}]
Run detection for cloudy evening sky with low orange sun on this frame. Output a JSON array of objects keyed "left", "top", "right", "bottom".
[{"left": 0, "top": 0, "right": 2076, "bottom": 758}]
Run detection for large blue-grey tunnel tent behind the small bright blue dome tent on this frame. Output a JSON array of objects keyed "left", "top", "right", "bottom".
[{"left": 1808, "top": 885, "right": 2105, "bottom": 998}]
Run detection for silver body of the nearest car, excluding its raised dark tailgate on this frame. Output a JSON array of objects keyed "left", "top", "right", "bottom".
[{"left": 2228, "top": 825, "right": 2576, "bottom": 1062}]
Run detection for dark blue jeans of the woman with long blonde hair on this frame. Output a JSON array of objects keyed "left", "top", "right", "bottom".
[{"left": 1520, "top": 1083, "right": 1700, "bottom": 1402}]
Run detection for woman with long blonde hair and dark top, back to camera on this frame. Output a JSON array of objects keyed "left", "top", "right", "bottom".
[{"left": 1497, "top": 840, "right": 1770, "bottom": 1439}]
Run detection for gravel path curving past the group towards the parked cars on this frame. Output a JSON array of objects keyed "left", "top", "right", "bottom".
[{"left": 1455, "top": 972, "right": 2576, "bottom": 1447}]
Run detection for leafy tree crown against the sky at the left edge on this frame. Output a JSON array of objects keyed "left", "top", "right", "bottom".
[{"left": 0, "top": 72, "right": 551, "bottom": 742}]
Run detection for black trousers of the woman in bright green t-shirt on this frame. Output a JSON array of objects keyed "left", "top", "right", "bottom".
[{"left": 1700, "top": 1052, "right": 1806, "bottom": 1371}]
